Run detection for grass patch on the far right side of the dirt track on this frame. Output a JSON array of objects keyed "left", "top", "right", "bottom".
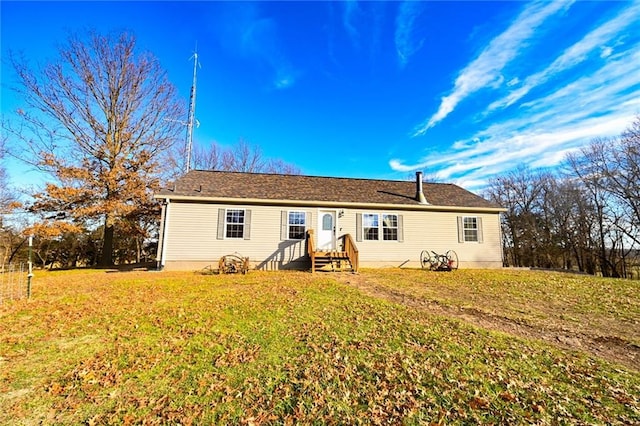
[{"left": 350, "top": 269, "right": 640, "bottom": 346}]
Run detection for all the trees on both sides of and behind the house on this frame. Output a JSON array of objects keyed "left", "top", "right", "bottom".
[{"left": 0, "top": 32, "right": 640, "bottom": 276}]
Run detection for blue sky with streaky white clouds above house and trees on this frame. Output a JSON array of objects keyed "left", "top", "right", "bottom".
[{"left": 0, "top": 1, "right": 640, "bottom": 190}]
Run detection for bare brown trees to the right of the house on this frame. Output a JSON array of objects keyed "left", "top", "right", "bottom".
[{"left": 483, "top": 116, "right": 640, "bottom": 278}]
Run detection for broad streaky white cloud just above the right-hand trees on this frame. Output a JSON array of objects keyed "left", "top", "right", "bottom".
[{"left": 389, "top": 43, "right": 640, "bottom": 190}]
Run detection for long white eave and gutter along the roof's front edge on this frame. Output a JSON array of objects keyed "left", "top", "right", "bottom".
[{"left": 154, "top": 194, "right": 507, "bottom": 213}]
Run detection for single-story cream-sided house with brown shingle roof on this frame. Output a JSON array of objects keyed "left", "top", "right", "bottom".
[{"left": 155, "top": 170, "right": 504, "bottom": 271}]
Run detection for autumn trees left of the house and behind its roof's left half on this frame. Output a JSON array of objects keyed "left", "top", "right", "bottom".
[{"left": 0, "top": 31, "right": 299, "bottom": 267}]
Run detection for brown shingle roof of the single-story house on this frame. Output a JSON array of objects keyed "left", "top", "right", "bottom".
[{"left": 156, "top": 170, "right": 500, "bottom": 209}]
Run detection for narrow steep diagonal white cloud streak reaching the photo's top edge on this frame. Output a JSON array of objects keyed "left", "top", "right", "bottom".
[{"left": 414, "top": 1, "right": 573, "bottom": 136}]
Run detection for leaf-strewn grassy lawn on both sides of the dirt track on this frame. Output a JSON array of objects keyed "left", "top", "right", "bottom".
[{"left": 0, "top": 269, "right": 640, "bottom": 425}]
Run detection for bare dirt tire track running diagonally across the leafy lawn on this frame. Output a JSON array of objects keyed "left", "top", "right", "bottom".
[{"left": 336, "top": 274, "right": 640, "bottom": 371}]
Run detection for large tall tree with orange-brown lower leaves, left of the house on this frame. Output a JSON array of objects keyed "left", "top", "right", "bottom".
[{"left": 9, "top": 32, "right": 183, "bottom": 265}]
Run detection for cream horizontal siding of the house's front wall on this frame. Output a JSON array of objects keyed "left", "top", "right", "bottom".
[{"left": 162, "top": 201, "right": 502, "bottom": 270}]
